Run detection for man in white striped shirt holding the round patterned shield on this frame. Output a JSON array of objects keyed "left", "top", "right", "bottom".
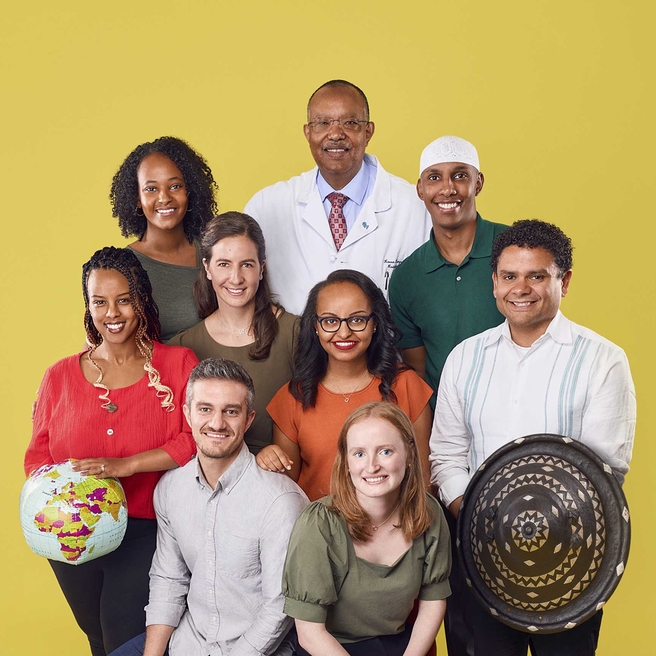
[{"left": 430, "top": 220, "right": 636, "bottom": 656}]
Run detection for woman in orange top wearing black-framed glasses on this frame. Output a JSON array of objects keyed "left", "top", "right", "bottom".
[{"left": 257, "top": 269, "right": 432, "bottom": 501}]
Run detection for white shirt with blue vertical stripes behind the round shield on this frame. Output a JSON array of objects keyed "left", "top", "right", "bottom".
[{"left": 430, "top": 312, "right": 636, "bottom": 506}]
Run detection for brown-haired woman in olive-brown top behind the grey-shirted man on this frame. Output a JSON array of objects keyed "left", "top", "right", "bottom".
[{"left": 168, "top": 212, "right": 298, "bottom": 454}]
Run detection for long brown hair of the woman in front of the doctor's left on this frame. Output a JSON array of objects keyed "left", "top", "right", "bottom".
[{"left": 194, "top": 212, "right": 283, "bottom": 360}]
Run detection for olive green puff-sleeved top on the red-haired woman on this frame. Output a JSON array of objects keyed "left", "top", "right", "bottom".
[{"left": 282, "top": 494, "right": 451, "bottom": 643}]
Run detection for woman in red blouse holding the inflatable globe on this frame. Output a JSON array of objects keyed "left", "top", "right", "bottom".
[{"left": 24, "top": 247, "right": 198, "bottom": 656}]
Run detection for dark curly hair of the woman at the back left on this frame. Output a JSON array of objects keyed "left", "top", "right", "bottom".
[{"left": 109, "top": 137, "right": 218, "bottom": 243}]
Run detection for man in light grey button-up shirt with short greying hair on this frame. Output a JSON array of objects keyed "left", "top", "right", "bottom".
[{"left": 114, "top": 359, "right": 308, "bottom": 656}]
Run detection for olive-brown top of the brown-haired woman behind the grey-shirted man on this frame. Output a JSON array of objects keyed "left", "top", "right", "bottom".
[{"left": 167, "top": 310, "right": 298, "bottom": 455}]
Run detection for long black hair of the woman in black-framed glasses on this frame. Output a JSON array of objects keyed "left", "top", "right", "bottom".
[{"left": 289, "top": 269, "right": 408, "bottom": 410}]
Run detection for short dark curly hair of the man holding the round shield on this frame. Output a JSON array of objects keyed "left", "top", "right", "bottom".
[{"left": 490, "top": 219, "right": 574, "bottom": 278}]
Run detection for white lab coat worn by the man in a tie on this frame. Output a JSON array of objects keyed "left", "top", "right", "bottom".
[{"left": 244, "top": 155, "right": 431, "bottom": 314}]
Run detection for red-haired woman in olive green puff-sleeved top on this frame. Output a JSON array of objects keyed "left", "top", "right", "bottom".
[{"left": 283, "top": 402, "right": 451, "bottom": 656}]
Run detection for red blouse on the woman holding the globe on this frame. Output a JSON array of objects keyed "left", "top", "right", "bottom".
[{"left": 24, "top": 343, "right": 198, "bottom": 519}]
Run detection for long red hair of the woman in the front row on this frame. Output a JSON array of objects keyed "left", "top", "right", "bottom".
[{"left": 329, "top": 401, "right": 433, "bottom": 542}]
